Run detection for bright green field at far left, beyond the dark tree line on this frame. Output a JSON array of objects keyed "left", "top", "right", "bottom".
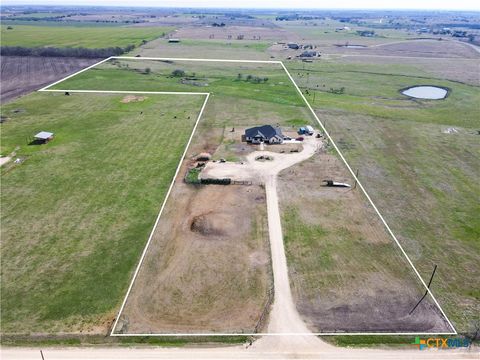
[{"left": 1, "top": 25, "right": 172, "bottom": 48}]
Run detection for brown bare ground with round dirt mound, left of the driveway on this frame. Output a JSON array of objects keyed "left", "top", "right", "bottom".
[{"left": 116, "top": 181, "right": 271, "bottom": 333}]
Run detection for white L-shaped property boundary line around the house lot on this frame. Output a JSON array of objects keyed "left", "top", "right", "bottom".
[{"left": 39, "top": 56, "right": 457, "bottom": 337}]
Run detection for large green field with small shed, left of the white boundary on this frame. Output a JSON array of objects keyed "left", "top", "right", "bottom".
[{"left": 1, "top": 93, "right": 204, "bottom": 334}]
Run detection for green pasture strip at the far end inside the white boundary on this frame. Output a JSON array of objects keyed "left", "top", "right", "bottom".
[{"left": 49, "top": 60, "right": 304, "bottom": 107}]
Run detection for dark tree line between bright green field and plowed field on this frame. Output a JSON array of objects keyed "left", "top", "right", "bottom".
[{"left": 0, "top": 45, "right": 135, "bottom": 58}]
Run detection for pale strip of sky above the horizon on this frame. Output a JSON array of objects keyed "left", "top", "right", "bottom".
[{"left": 2, "top": 0, "right": 480, "bottom": 11}]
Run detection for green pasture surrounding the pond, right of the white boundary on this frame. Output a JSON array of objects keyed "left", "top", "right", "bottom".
[{"left": 287, "top": 61, "right": 480, "bottom": 127}]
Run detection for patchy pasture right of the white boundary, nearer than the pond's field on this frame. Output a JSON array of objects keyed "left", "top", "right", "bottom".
[{"left": 320, "top": 110, "right": 480, "bottom": 332}]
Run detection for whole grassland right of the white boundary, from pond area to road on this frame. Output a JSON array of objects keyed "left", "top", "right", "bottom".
[{"left": 288, "top": 60, "right": 480, "bottom": 332}]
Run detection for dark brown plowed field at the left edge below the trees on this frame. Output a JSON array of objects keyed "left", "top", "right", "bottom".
[{"left": 0, "top": 56, "right": 100, "bottom": 103}]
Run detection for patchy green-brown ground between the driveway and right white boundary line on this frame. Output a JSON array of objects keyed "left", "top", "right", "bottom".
[{"left": 278, "top": 154, "right": 450, "bottom": 332}]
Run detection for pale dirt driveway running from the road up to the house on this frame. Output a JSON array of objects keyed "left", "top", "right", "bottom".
[{"left": 201, "top": 136, "right": 331, "bottom": 352}]
